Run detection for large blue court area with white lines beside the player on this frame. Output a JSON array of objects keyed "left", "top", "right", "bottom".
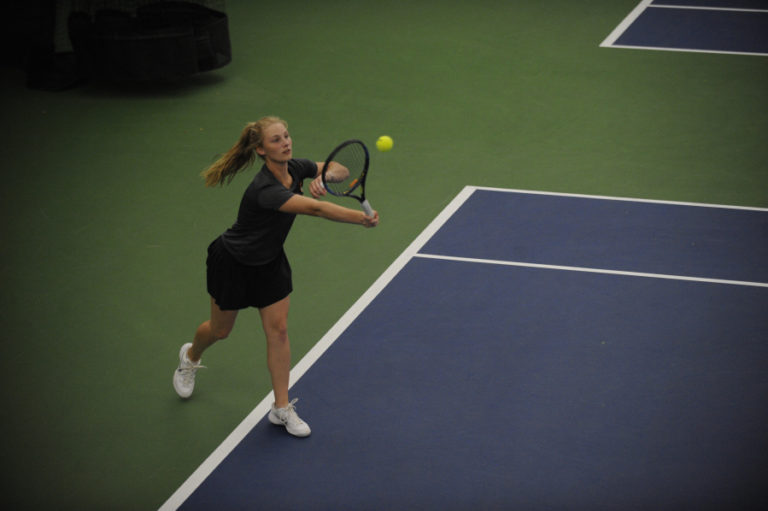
[{"left": 164, "top": 187, "right": 768, "bottom": 510}]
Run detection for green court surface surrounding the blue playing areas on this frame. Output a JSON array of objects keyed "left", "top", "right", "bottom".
[{"left": 0, "top": 0, "right": 768, "bottom": 510}]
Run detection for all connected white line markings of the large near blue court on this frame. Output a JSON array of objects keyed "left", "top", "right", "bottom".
[{"left": 159, "top": 186, "right": 768, "bottom": 511}]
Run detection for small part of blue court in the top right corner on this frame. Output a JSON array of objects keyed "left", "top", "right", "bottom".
[{"left": 601, "top": 0, "right": 768, "bottom": 55}]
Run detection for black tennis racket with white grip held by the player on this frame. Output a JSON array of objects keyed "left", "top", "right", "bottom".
[{"left": 323, "top": 140, "right": 373, "bottom": 216}]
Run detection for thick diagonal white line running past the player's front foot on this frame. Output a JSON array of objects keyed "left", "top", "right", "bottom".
[{"left": 159, "top": 187, "right": 474, "bottom": 511}]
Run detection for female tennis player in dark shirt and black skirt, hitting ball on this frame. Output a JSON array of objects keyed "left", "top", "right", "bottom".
[{"left": 173, "top": 117, "right": 379, "bottom": 436}]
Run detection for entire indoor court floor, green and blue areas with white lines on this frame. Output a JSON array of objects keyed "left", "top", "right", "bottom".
[{"left": 0, "top": 0, "right": 768, "bottom": 510}]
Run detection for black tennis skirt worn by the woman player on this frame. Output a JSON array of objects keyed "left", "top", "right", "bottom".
[{"left": 206, "top": 238, "right": 293, "bottom": 310}]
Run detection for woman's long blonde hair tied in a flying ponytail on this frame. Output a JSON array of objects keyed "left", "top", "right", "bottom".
[{"left": 200, "top": 116, "right": 288, "bottom": 187}]
